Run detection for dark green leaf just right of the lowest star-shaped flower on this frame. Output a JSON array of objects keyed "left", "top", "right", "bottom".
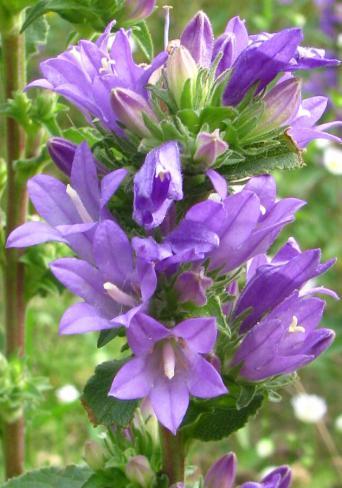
[{"left": 181, "top": 385, "right": 264, "bottom": 441}]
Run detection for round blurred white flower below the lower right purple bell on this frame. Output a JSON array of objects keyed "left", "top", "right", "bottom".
[{"left": 291, "top": 393, "right": 327, "bottom": 424}]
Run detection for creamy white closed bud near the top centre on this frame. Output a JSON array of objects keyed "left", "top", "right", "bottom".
[{"left": 166, "top": 46, "right": 198, "bottom": 105}]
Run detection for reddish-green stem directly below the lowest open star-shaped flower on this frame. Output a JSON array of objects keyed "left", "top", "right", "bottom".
[{"left": 160, "top": 426, "right": 185, "bottom": 485}]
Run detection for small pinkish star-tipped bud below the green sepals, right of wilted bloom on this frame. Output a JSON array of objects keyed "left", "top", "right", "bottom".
[{"left": 194, "top": 129, "right": 229, "bottom": 166}]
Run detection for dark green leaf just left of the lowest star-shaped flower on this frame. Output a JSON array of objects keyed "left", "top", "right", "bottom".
[{"left": 82, "top": 361, "right": 138, "bottom": 427}]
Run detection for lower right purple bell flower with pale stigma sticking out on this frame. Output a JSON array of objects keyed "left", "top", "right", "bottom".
[{"left": 232, "top": 288, "right": 335, "bottom": 381}]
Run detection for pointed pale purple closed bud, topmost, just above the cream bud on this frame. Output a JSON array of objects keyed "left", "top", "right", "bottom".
[{"left": 180, "top": 11, "right": 214, "bottom": 68}]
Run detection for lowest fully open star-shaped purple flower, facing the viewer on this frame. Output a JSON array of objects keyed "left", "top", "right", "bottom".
[{"left": 109, "top": 314, "right": 227, "bottom": 434}]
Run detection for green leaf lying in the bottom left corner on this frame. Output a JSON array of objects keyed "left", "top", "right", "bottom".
[{"left": 3, "top": 466, "right": 92, "bottom": 488}]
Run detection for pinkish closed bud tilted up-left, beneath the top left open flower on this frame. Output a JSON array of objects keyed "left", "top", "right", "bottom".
[{"left": 112, "top": 88, "right": 157, "bottom": 137}]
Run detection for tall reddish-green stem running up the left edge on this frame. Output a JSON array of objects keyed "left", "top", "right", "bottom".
[{"left": 1, "top": 16, "right": 27, "bottom": 478}]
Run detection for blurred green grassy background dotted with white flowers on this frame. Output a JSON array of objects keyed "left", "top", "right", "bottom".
[{"left": 0, "top": 0, "right": 342, "bottom": 488}]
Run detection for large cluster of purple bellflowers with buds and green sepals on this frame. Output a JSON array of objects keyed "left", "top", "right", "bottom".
[{"left": 7, "top": 8, "right": 338, "bottom": 446}]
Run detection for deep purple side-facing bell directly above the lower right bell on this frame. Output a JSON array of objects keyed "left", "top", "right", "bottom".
[{"left": 234, "top": 236, "right": 335, "bottom": 332}]
